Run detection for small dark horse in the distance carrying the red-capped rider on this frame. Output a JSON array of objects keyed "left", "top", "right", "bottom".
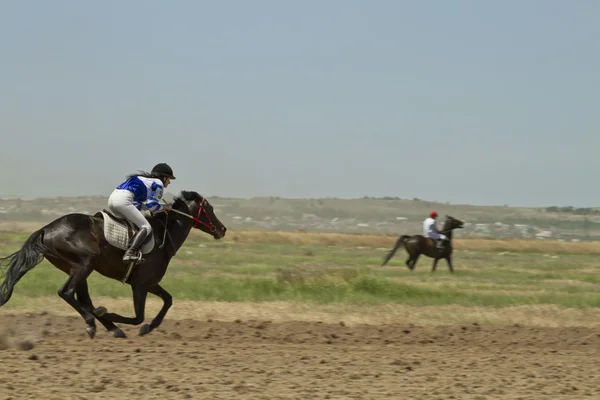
[{"left": 381, "top": 215, "right": 464, "bottom": 272}]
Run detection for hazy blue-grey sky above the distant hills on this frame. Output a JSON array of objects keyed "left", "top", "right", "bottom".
[{"left": 0, "top": 0, "right": 600, "bottom": 206}]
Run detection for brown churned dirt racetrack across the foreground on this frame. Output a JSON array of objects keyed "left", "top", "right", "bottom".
[{"left": 0, "top": 313, "right": 600, "bottom": 400}]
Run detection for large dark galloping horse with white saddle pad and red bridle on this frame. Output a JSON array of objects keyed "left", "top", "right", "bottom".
[{"left": 0, "top": 191, "right": 227, "bottom": 338}]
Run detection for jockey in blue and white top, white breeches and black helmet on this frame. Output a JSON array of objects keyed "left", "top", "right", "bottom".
[{"left": 108, "top": 163, "right": 175, "bottom": 262}]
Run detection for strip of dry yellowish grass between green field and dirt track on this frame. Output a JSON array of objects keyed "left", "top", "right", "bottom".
[{"left": 0, "top": 296, "right": 600, "bottom": 330}]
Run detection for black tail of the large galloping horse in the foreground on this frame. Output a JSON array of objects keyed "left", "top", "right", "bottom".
[{"left": 0, "top": 229, "right": 46, "bottom": 307}]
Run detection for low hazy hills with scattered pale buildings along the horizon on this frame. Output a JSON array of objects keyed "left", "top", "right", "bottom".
[{"left": 0, "top": 194, "right": 600, "bottom": 240}]
